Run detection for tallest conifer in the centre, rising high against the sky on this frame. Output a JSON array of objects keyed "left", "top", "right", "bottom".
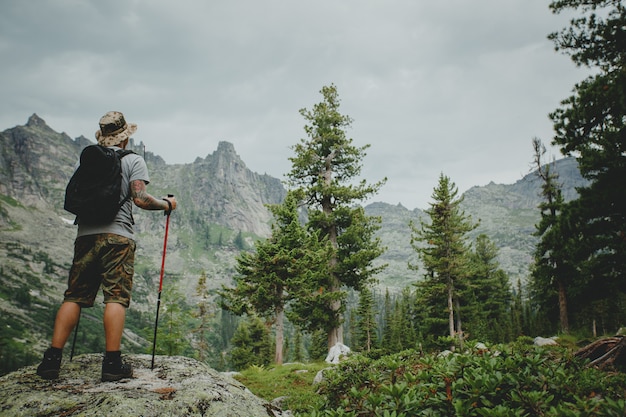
[{"left": 288, "top": 85, "right": 385, "bottom": 348}]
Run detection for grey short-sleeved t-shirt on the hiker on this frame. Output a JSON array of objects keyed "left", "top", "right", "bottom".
[{"left": 77, "top": 146, "right": 150, "bottom": 239}]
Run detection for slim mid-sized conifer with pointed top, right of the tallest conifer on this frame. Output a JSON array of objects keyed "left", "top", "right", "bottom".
[{"left": 409, "top": 174, "right": 477, "bottom": 344}]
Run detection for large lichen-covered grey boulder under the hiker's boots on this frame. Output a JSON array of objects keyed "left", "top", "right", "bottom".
[{"left": 0, "top": 354, "right": 286, "bottom": 417}]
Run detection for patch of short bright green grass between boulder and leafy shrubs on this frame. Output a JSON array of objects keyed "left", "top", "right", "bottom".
[{"left": 235, "top": 362, "right": 331, "bottom": 412}]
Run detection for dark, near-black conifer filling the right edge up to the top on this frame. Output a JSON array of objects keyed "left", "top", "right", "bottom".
[{"left": 550, "top": 0, "right": 626, "bottom": 329}]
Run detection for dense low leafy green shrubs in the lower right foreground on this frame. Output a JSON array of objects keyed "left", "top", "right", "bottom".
[{"left": 300, "top": 343, "right": 626, "bottom": 417}]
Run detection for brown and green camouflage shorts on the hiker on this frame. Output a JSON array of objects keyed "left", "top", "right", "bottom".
[{"left": 64, "top": 233, "right": 135, "bottom": 307}]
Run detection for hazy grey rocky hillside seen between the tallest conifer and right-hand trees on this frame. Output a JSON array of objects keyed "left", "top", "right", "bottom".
[{"left": 365, "top": 158, "right": 587, "bottom": 288}]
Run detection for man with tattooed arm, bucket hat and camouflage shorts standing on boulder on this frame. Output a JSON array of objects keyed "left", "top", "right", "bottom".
[{"left": 37, "top": 111, "right": 176, "bottom": 381}]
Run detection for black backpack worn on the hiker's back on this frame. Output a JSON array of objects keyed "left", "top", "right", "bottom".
[{"left": 63, "top": 145, "right": 134, "bottom": 225}]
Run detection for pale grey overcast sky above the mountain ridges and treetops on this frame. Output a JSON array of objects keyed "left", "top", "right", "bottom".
[{"left": 0, "top": 0, "right": 586, "bottom": 209}]
